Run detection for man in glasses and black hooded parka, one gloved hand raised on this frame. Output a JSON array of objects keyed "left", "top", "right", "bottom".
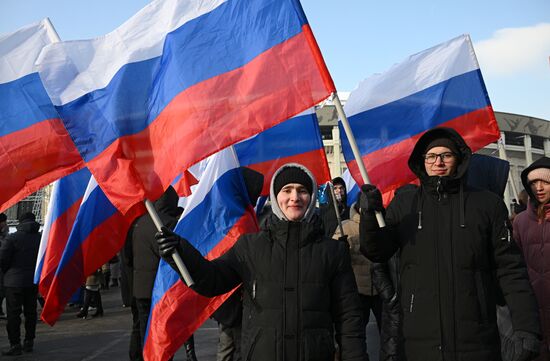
[{"left": 360, "top": 128, "right": 540, "bottom": 361}]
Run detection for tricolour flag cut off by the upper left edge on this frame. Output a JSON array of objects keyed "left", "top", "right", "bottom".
[{"left": 0, "top": 20, "right": 84, "bottom": 211}]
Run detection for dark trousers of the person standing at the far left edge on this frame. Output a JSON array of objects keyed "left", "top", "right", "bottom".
[{"left": 5, "top": 285, "right": 38, "bottom": 345}]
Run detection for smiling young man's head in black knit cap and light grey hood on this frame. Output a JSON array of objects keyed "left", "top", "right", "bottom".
[{"left": 270, "top": 163, "right": 317, "bottom": 222}]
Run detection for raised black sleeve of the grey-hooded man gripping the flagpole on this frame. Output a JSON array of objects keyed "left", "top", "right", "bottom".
[{"left": 169, "top": 237, "right": 242, "bottom": 297}]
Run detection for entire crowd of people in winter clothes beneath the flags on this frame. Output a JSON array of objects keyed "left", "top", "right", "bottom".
[{"left": 0, "top": 128, "right": 550, "bottom": 361}]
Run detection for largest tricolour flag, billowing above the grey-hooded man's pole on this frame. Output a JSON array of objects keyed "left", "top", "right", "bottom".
[{"left": 38, "top": 0, "right": 334, "bottom": 213}]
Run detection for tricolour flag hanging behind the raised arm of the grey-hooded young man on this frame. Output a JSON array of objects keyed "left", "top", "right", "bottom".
[{"left": 143, "top": 147, "right": 258, "bottom": 361}]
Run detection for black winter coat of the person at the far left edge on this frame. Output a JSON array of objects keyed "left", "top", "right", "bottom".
[{"left": 0, "top": 220, "right": 41, "bottom": 287}]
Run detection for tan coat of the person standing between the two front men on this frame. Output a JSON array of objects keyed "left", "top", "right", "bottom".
[{"left": 332, "top": 202, "right": 378, "bottom": 296}]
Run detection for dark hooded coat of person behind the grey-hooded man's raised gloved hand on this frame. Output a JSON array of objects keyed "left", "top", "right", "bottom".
[{"left": 126, "top": 187, "right": 181, "bottom": 299}]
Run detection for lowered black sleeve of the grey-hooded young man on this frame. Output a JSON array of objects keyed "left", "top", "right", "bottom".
[{"left": 331, "top": 242, "right": 368, "bottom": 361}]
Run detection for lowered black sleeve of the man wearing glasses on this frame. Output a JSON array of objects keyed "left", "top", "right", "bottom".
[{"left": 491, "top": 201, "right": 541, "bottom": 335}]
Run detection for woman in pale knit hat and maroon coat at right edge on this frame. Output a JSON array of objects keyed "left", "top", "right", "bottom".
[{"left": 513, "top": 157, "right": 550, "bottom": 361}]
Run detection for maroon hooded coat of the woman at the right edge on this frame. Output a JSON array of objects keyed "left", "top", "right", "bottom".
[{"left": 514, "top": 158, "right": 550, "bottom": 348}]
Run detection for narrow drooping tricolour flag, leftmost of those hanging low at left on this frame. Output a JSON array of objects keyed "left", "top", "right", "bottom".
[{"left": 34, "top": 168, "right": 91, "bottom": 296}]
